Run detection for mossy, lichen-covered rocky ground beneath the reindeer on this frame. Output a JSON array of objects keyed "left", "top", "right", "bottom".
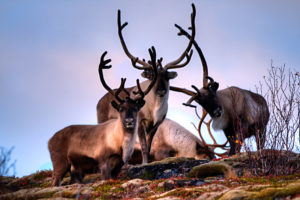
[{"left": 0, "top": 154, "right": 300, "bottom": 200}]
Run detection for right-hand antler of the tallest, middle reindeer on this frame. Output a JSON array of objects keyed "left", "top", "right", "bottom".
[{"left": 165, "top": 4, "right": 196, "bottom": 70}]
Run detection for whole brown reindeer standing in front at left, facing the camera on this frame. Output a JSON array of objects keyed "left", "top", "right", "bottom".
[{"left": 48, "top": 48, "right": 157, "bottom": 186}]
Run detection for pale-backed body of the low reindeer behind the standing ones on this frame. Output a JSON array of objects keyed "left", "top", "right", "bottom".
[{"left": 129, "top": 119, "right": 214, "bottom": 164}]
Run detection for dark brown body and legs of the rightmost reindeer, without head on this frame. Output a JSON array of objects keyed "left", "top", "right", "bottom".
[{"left": 211, "top": 87, "right": 270, "bottom": 155}]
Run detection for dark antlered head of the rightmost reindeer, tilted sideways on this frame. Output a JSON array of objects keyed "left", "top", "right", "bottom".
[{"left": 170, "top": 25, "right": 222, "bottom": 117}]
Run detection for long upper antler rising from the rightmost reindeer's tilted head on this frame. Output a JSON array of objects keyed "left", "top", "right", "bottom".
[{"left": 175, "top": 24, "right": 208, "bottom": 88}]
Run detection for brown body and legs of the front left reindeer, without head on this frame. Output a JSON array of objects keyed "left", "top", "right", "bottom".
[{"left": 48, "top": 119, "right": 137, "bottom": 185}]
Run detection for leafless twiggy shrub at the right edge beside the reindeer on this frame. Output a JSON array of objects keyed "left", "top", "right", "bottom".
[{"left": 244, "top": 63, "right": 300, "bottom": 176}]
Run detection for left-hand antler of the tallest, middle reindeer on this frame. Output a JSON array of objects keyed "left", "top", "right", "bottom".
[{"left": 118, "top": 10, "right": 151, "bottom": 69}]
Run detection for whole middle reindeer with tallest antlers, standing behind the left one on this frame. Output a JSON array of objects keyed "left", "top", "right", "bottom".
[{"left": 97, "top": 4, "right": 196, "bottom": 163}]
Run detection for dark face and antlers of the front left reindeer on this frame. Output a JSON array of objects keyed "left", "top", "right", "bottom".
[{"left": 99, "top": 47, "right": 157, "bottom": 129}]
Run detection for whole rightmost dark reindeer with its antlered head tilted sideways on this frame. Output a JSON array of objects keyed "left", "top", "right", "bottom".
[{"left": 170, "top": 25, "right": 269, "bottom": 155}]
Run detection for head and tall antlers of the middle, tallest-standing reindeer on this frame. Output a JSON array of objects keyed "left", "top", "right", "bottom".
[{"left": 118, "top": 4, "right": 196, "bottom": 98}]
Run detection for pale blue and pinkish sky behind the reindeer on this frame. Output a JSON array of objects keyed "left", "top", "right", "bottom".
[{"left": 0, "top": 0, "right": 300, "bottom": 176}]
